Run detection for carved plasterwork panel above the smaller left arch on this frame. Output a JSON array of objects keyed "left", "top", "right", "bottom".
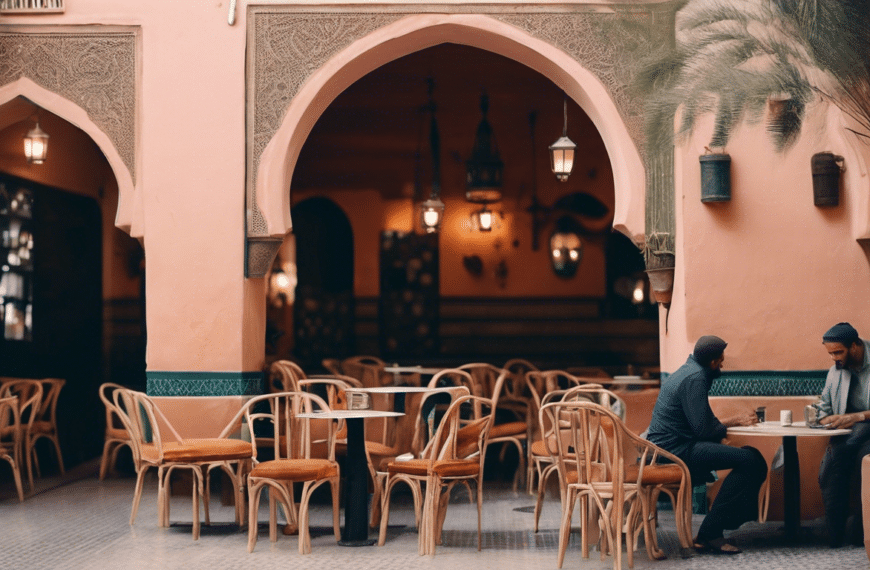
[{"left": 0, "top": 26, "right": 137, "bottom": 181}]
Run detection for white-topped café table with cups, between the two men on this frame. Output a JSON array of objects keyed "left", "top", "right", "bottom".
[{"left": 728, "top": 422, "right": 852, "bottom": 540}]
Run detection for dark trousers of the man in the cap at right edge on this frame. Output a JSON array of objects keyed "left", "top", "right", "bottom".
[{"left": 819, "top": 422, "right": 870, "bottom": 542}]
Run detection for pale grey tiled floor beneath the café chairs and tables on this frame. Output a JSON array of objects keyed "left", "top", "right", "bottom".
[{"left": 0, "top": 460, "right": 870, "bottom": 570}]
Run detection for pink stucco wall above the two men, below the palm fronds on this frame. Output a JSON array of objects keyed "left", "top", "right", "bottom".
[{"left": 662, "top": 104, "right": 870, "bottom": 371}]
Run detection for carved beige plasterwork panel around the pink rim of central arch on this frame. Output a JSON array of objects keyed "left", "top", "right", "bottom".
[{"left": 247, "top": 2, "right": 674, "bottom": 236}]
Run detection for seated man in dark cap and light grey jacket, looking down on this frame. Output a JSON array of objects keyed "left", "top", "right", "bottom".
[{"left": 819, "top": 323, "right": 870, "bottom": 548}]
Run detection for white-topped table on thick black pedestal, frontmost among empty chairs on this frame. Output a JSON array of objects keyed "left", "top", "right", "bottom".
[{"left": 297, "top": 410, "right": 404, "bottom": 546}]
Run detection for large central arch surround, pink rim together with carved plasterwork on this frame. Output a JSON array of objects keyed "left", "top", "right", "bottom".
[{"left": 245, "top": 2, "right": 671, "bottom": 277}]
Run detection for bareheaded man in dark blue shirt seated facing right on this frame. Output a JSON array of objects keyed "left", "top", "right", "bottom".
[{"left": 647, "top": 336, "right": 767, "bottom": 554}]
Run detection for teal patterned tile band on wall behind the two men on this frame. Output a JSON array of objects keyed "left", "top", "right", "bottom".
[{"left": 662, "top": 370, "right": 828, "bottom": 396}]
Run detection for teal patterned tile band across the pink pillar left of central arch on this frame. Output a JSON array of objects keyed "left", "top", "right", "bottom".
[{"left": 145, "top": 370, "right": 263, "bottom": 396}]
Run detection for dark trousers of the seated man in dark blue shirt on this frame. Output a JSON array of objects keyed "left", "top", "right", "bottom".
[{"left": 682, "top": 441, "right": 767, "bottom": 542}]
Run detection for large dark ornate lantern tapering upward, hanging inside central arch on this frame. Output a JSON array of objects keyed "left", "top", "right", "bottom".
[{"left": 465, "top": 93, "right": 504, "bottom": 204}]
